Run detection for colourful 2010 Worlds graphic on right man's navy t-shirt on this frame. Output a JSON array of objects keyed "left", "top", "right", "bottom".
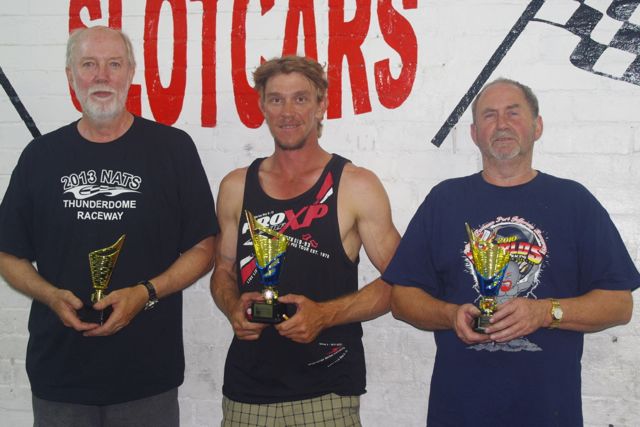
[{"left": 464, "top": 216, "right": 547, "bottom": 351}]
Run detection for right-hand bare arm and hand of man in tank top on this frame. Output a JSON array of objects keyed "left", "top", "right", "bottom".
[{"left": 276, "top": 165, "right": 400, "bottom": 342}]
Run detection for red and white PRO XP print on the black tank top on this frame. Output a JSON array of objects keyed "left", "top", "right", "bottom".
[{"left": 240, "top": 173, "right": 334, "bottom": 284}]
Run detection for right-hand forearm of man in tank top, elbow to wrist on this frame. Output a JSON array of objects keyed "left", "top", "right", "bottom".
[{"left": 320, "top": 278, "right": 391, "bottom": 327}]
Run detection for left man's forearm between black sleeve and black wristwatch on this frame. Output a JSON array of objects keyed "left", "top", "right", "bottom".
[{"left": 148, "top": 236, "right": 214, "bottom": 298}]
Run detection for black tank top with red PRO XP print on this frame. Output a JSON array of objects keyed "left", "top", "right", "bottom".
[{"left": 222, "top": 154, "right": 365, "bottom": 403}]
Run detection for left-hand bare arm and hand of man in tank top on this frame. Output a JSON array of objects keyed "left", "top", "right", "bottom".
[{"left": 211, "top": 169, "right": 266, "bottom": 340}]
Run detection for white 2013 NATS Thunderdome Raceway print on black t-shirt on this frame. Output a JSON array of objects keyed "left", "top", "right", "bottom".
[{"left": 60, "top": 169, "right": 142, "bottom": 221}]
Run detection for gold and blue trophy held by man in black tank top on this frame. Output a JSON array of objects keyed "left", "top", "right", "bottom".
[{"left": 244, "top": 210, "right": 292, "bottom": 323}]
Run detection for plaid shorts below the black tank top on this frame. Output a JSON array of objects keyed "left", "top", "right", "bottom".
[{"left": 220, "top": 393, "right": 361, "bottom": 427}]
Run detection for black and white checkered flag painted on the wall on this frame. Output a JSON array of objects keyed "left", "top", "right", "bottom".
[{"left": 532, "top": 0, "right": 640, "bottom": 85}]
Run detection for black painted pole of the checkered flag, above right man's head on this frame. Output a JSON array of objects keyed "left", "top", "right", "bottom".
[{"left": 431, "top": 0, "right": 544, "bottom": 147}]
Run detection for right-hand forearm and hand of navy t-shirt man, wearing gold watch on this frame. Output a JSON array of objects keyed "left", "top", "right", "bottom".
[{"left": 487, "top": 289, "right": 633, "bottom": 342}]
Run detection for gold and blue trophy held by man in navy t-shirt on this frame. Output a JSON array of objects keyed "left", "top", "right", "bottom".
[{"left": 465, "top": 223, "right": 511, "bottom": 334}]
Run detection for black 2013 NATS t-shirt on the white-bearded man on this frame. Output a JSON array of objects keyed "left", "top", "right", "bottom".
[{"left": 0, "top": 117, "right": 218, "bottom": 405}]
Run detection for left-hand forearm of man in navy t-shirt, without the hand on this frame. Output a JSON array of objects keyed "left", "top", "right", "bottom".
[{"left": 391, "top": 286, "right": 459, "bottom": 331}]
